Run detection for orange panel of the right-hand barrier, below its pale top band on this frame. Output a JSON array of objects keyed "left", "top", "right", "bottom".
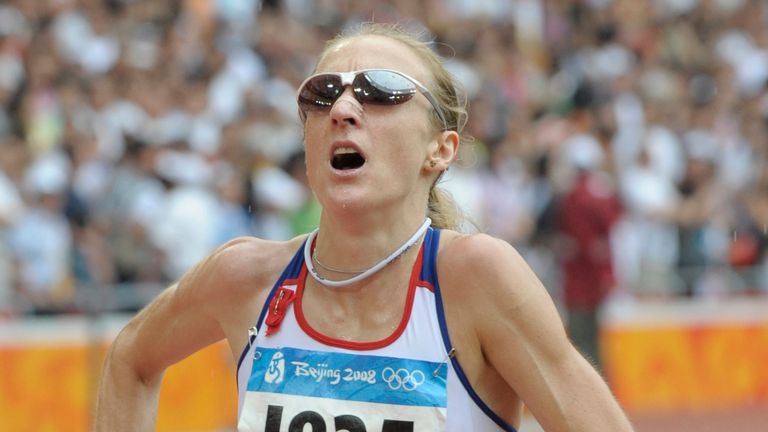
[{"left": 604, "top": 325, "right": 768, "bottom": 410}]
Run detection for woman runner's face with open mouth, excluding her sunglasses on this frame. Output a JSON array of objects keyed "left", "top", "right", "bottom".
[{"left": 305, "top": 36, "right": 441, "bottom": 216}]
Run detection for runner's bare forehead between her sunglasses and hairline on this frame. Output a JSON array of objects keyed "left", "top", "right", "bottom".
[{"left": 317, "top": 35, "right": 428, "bottom": 81}]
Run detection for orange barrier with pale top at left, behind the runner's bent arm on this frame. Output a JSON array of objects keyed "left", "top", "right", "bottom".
[{"left": 0, "top": 318, "right": 237, "bottom": 432}]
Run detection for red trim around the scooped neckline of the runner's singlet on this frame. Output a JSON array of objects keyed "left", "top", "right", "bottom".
[{"left": 294, "top": 244, "right": 424, "bottom": 351}]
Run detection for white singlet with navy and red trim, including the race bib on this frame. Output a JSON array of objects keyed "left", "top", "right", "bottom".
[{"left": 237, "top": 228, "right": 515, "bottom": 432}]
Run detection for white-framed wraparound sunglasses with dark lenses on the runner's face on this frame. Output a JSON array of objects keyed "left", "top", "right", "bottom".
[{"left": 297, "top": 69, "right": 448, "bottom": 130}]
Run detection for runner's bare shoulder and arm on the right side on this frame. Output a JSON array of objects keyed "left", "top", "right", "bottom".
[{"left": 437, "top": 231, "right": 632, "bottom": 431}]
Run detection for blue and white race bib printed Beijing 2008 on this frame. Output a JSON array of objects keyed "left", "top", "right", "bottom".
[{"left": 238, "top": 348, "right": 447, "bottom": 432}]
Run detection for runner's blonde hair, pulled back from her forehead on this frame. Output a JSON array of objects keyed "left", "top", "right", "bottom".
[{"left": 318, "top": 23, "right": 467, "bottom": 229}]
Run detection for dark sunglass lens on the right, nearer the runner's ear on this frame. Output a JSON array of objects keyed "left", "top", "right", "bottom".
[{"left": 354, "top": 71, "right": 416, "bottom": 105}]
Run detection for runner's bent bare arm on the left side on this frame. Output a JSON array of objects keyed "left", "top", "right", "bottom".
[{"left": 94, "top": 240, "right": 272, "bottom": 432}]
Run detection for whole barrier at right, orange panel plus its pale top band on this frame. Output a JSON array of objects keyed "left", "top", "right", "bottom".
[{"left": 602, "top": 299, "right": 768, "bottom": 411}]
